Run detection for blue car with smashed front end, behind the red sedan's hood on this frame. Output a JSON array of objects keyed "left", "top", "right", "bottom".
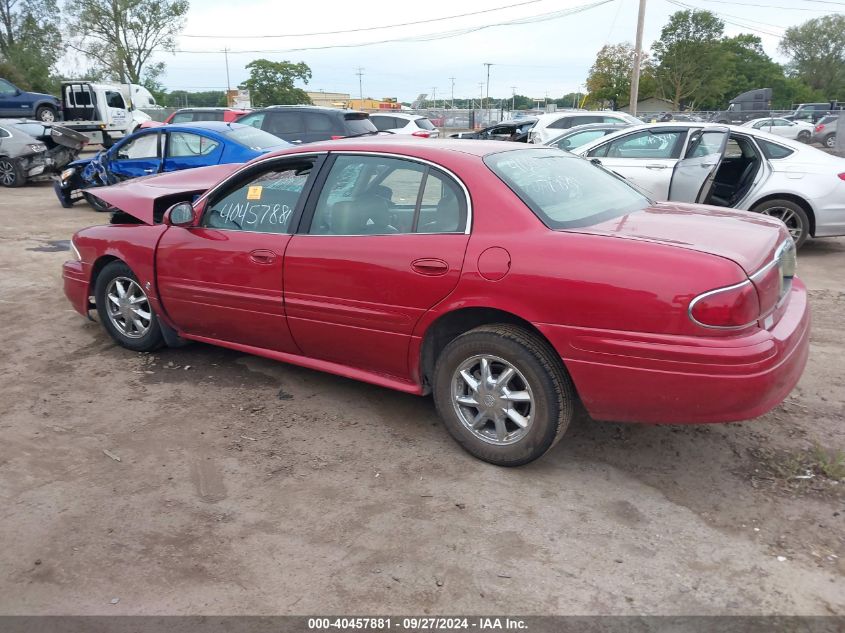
[{"left": 53, "top": 121, "right": 293, "bottom": 211}]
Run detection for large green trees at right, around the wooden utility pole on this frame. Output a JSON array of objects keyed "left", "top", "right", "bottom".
[{"left": 587, "top": 10, "right": 845, "bottom": 110}]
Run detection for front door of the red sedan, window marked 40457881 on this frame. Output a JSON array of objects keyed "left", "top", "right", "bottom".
[{"left": 156, "top": 156, "right": 317, "bottom": 353}]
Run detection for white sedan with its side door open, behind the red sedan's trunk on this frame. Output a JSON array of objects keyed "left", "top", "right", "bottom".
[{"left": 576, "top": 123, "right": 845, "bottom": 247}]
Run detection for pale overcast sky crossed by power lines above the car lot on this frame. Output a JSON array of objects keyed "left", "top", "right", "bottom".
[{"left": 125, "top": 0, "right": 845, "bottom": 101}]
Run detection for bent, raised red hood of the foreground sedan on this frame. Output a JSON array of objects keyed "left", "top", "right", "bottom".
[{"left": 93, "top": 163, "right": 243, "bottom": 225}]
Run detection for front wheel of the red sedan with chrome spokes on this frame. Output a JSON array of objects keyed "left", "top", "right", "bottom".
[{"left": 94, "top": 261, "right": 164, "bottom": 352}]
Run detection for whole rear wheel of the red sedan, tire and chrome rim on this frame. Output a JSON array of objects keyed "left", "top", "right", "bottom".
[{"left": 434, "top": 325, "right": 575, "bottom": 466}]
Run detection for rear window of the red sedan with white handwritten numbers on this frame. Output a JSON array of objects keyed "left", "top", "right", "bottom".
[{"left": 484, "top": 149, "right": 651, "bottom": 229}]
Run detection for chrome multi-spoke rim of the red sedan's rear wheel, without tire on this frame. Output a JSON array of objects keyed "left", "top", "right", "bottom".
[{"left": 452, "top": 354, "right": 535, "bottom": 446}]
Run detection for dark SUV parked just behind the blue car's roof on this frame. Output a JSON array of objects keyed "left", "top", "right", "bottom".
[{"left": 232, "top": 106, "right": 378, "bottom": 144}]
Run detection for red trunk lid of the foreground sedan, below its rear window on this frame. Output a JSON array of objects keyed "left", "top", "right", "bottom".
[{"left": 577, "top": 202, "right": 789, "bottom": 275}]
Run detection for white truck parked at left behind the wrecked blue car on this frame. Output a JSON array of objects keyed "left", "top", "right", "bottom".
[{"left": 61, "top": 81, "right": 155, "bottom": 147}]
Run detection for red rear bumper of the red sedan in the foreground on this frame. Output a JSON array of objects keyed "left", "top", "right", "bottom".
[{"left": 538, "top": 279, "right": 810, "bottom": 424}]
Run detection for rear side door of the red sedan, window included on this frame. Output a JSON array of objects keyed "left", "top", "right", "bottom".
[{"left": 284, "top": 154, "right": 469, "bottom": 378}]
